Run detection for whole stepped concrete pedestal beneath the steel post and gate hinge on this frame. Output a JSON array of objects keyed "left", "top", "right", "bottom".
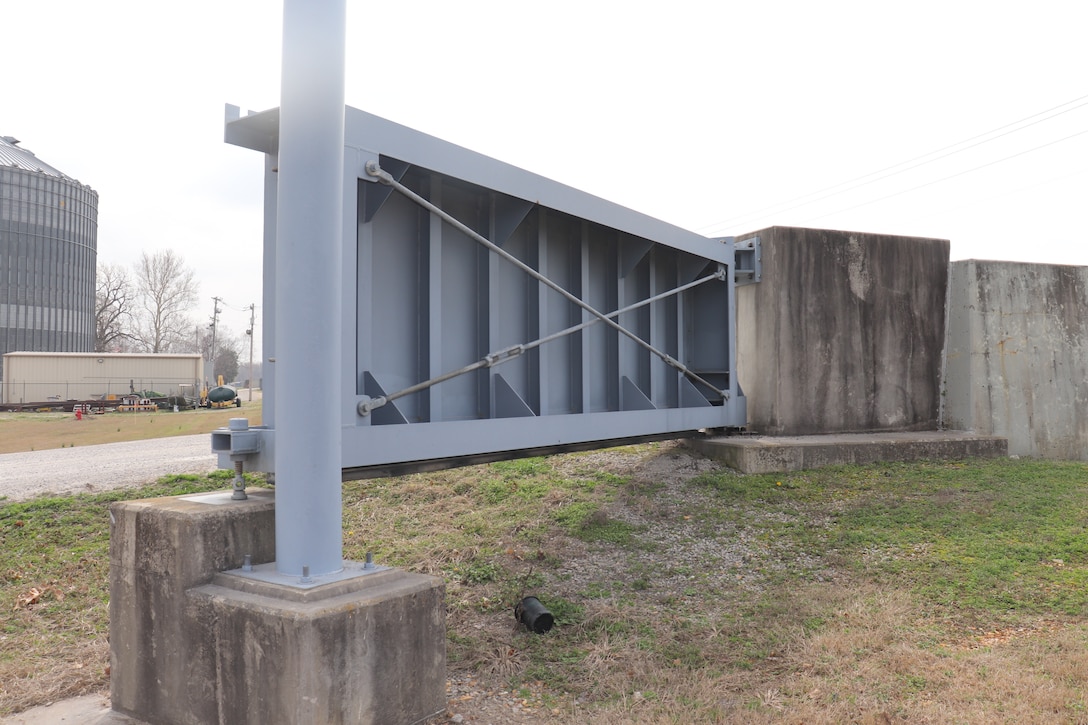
[{"left": 110, "top": 491, "right": 446, "bottom": 725}]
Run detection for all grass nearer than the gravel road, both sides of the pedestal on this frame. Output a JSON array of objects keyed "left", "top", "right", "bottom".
[{"left": 0, "top": 444, "right": 1088, "bottom": 724}]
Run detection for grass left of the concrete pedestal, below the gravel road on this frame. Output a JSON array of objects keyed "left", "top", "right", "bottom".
[{"left": 0, "top": 471, "right": 242, "bottom": 715}]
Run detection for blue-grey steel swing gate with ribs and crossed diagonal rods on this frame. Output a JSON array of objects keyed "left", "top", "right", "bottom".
[{"left": 218, "top": 107, "right": 758, "bottom": 479}]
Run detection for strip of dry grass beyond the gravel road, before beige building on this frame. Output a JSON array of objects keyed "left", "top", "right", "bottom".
[{"left": 0, "top": 393, "right": 261, "bottom": 454}]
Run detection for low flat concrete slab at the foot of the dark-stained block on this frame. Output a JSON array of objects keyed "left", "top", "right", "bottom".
[{"left": 688, "top": 431, "right": 1009, "bottom": 474}]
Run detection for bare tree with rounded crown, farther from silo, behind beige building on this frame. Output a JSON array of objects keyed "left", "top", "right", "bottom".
[{"left": 136, "top": 249, "right": 198, "bottom": 353}]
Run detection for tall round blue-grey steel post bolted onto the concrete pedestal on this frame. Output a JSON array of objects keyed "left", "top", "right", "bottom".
[{"left": 274, "top": 0, "right": 346, "bottom": 576}]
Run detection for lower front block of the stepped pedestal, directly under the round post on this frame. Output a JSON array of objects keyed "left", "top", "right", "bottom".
[{"left": 189, "top": 569, "right": 446, "bottom": 725}]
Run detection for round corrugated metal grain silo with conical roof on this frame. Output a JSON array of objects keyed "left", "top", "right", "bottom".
[{"left": 0, "top": 136, "right": 98, "bottom": 374}]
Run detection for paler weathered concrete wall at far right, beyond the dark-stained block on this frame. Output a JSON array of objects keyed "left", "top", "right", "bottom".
[{"left": 943, "top": 259, "right": 1088, "bottom": 460}]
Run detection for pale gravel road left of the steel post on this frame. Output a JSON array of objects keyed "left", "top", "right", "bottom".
[{"left": 0, "top": 433, "right": 218, "bottom": 503}]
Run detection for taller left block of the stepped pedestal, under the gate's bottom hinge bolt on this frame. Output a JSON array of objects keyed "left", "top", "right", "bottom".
[{"left": 110, "top": 490, "right": 275, "bottom": 723}]
